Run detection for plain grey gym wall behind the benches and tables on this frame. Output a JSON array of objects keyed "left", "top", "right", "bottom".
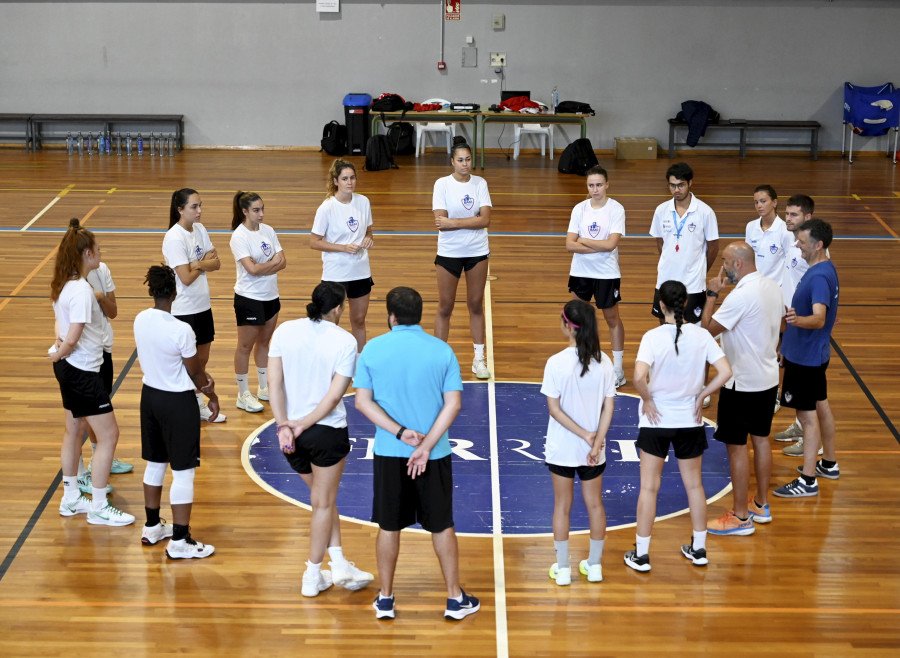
[{"left": 0, "top": 0, "right": 900, "bottom": 150}]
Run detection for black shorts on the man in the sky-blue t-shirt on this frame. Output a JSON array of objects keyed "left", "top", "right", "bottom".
[{"left": 372, "top": 455, "right": 453, "bottom": 533}]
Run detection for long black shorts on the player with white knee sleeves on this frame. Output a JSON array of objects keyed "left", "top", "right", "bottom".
[{"left": 141, "top": 384, "right": 200, "bottom": 471}]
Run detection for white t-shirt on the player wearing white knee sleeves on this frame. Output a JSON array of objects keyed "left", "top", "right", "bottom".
[{"left": 134, "top": 308, "right": 197, "bottom": 393}]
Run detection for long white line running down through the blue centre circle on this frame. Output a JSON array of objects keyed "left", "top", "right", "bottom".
[{"left": 484, "top": 264, "right": 509, "bottom": 658}]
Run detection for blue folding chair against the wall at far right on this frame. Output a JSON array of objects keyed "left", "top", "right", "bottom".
[{"left": 841, "top": 82, "right": 900, "bottom": 164}]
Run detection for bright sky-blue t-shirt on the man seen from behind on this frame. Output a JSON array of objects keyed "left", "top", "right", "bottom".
[{"left": 353, "top": 324, "right": 462, "bottom": 459}]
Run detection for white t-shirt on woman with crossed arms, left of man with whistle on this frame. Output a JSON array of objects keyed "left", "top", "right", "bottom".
[{"left": 567, "top": 197, "right": 625, "bottom": 279}]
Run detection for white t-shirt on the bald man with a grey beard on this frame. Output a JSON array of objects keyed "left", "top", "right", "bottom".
[{"left": 713, "top": 271, "right": 784, "bottom": 392}]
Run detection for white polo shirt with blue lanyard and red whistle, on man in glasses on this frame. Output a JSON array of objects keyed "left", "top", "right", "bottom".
[{"left": 650, "top": 194, "right": 719, "bottom": 294}]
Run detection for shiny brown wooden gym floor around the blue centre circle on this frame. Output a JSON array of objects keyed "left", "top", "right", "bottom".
[{"left": 0, "top": 149, "right": 900, "bottom": 656}]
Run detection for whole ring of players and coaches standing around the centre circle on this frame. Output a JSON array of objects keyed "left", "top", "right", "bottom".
[{"left": 49, "top": 145, "right": 839, "bottom": 619}]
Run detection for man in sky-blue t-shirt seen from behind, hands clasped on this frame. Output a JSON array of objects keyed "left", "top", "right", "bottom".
[{"left": 354, "top": 287, "right": 480, "bottom": 619}]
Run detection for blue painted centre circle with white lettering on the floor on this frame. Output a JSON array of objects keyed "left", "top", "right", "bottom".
[{"left": 243, "top": 382, "right": 731, "bottom": 536}]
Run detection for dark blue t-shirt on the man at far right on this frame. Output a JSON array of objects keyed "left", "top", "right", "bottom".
[{"left": 781, "top": 260, "right": 838, "bottom": 366}]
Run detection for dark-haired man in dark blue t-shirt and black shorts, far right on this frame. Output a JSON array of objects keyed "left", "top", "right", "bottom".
[{"left": 774, "top": 218, "right": 840, "bottom": 498}]
